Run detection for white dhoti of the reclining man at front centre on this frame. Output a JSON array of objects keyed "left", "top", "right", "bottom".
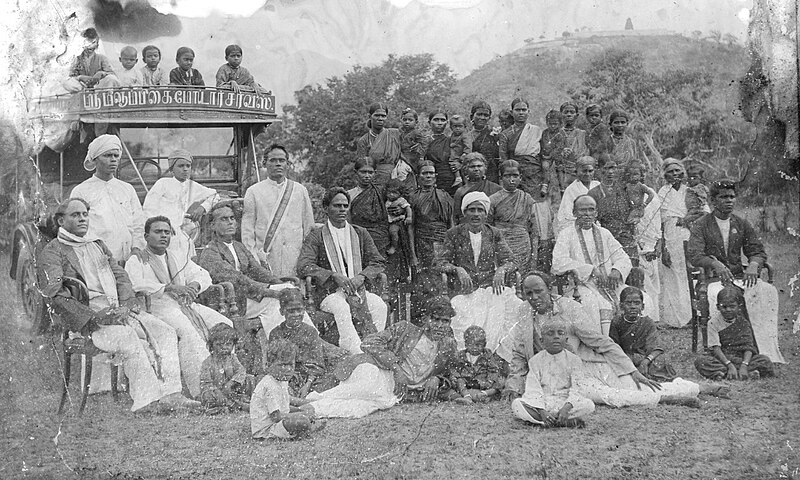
[{"left": 306, "top": 363, "right": 400, "bottom": 418}]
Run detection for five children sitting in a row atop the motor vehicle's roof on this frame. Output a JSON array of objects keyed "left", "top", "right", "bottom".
[{"left": 62, "top": 28, "right": 268, "bottom": 94}]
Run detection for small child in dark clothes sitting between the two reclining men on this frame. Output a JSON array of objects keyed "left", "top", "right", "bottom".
[{"left": 446, "top": 325, "right": 508, "bottom": 404}]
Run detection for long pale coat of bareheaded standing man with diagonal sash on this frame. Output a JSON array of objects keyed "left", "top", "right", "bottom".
[{"left": 242, "top": 178, "right": 314, "bottom": 277}]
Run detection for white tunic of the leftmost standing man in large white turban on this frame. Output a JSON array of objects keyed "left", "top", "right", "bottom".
[{"left": 70, "top": 175, "right": 145, "bottom": 261}]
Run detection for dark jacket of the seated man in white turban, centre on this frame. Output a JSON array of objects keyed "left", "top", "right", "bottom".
[{"left": 434, "top": 225, "right": 516, "bottom": 293}]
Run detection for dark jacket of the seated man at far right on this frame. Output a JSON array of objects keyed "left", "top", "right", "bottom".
[{"left": 689, "top": 213, "right": 767, "bottom": 277}]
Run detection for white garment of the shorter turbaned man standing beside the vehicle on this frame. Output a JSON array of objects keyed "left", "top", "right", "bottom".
[{"left": 142, "top": 177, "right": 219, "bottom": 268}]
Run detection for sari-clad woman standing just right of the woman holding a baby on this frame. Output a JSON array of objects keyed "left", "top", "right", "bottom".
[{"left": 409, "top": 160, "right": 453, "bottom": 270}]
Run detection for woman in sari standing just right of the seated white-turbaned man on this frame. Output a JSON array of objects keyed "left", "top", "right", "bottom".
[{"left": 489, "top": 160, "right": 539, "bottom": 278}]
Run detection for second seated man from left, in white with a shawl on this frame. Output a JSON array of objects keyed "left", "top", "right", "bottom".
[{"left": 125, "top": 216, "right": 233, "bottom": 397}]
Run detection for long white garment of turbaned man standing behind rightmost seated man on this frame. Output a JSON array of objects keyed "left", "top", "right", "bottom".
[{"left": 658, "top": 217, "right": 692, "bottom": 328}]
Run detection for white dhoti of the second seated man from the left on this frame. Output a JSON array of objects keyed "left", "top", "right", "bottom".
[{"left": 150, "top": 295, "right": 233, "bottom": 397}]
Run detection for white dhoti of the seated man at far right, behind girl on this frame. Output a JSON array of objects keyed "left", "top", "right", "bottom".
[{"left": 708, "top": 280, "right": 786, "bottom": 363}]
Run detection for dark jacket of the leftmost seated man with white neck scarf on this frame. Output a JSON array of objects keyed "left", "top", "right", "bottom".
[{"left": 38, "top": 238, "right": 136, "bottom": 334}]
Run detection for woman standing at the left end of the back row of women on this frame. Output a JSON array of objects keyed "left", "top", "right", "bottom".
[{"left": 356, "top": 103, "right": 404, "bottom": 188}]
